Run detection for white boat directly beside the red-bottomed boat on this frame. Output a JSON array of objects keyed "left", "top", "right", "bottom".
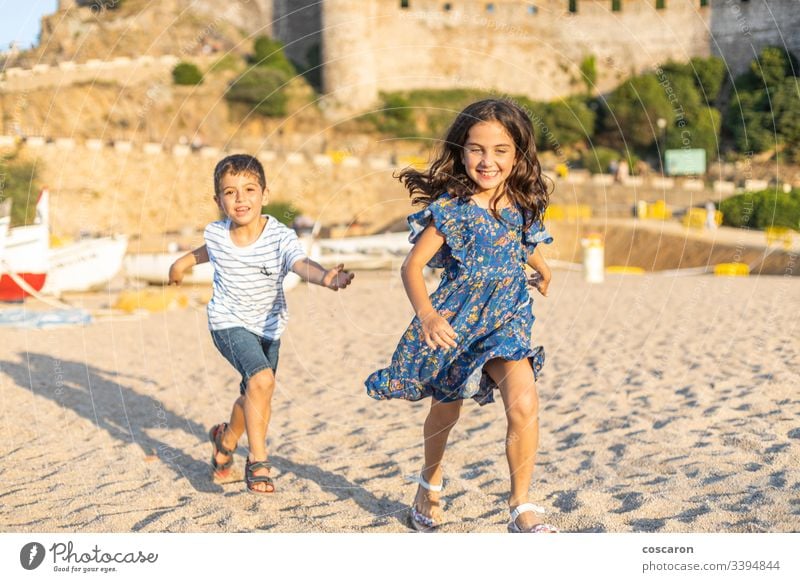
[{"left": 42, "top": 235, "right": 128, "bottom": 295}]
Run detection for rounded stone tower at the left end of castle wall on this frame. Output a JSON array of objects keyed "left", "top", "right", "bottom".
[{"left": 322, "top": 0, "right": 379, "bottom": 117}]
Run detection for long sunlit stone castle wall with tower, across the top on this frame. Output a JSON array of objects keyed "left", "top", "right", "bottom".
[{"left": 310, "top": 0, "right": 800, "bottom": 113}]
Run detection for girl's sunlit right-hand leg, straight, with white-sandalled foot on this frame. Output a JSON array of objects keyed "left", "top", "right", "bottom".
[{"left": 485, "top": 358, "right": 542, "bottom": 529}]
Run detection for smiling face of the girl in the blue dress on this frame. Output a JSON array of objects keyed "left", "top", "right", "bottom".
[{"left": 461, "top": 121, "right": 517, "bottom": 196}]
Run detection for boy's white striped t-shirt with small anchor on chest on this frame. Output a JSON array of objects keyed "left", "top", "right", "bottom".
[{"left": 203, "top": 215, "right": 306, "bottom": 339}]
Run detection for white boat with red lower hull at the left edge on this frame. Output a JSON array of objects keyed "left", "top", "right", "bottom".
[{"left": 0, "top": 189, "right": 50, "bottom": 301}]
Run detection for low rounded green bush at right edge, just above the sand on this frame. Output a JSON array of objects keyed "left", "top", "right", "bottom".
[{"left": 719, "top": 190, "right": 800, "bottom": 230}]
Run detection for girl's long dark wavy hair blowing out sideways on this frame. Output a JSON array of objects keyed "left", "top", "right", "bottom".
[{"left": 395, "top": 99, "right": 551, "bottom": 229}]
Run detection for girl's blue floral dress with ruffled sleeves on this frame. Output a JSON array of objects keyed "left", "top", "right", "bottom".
[{"left": 365, "top": 194, "right": 553, "bottom": 405}]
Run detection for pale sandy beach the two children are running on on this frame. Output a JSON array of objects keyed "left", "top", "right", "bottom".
[{"left": 0, "top": 271, "right": 800, "bottom": 532}]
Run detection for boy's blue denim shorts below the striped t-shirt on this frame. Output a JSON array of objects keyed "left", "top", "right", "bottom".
[{"left": 211, "top": 327, "right": 281, "bottom": 394}]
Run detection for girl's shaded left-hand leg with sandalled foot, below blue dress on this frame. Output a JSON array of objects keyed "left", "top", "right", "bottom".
[{"left": 414, "top": 398, "right": 462, "bottom": 522}]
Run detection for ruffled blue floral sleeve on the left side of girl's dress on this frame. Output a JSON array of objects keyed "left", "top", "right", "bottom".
[{"left": 408, "top": 195, "right": 468, "bottom": 269}]
